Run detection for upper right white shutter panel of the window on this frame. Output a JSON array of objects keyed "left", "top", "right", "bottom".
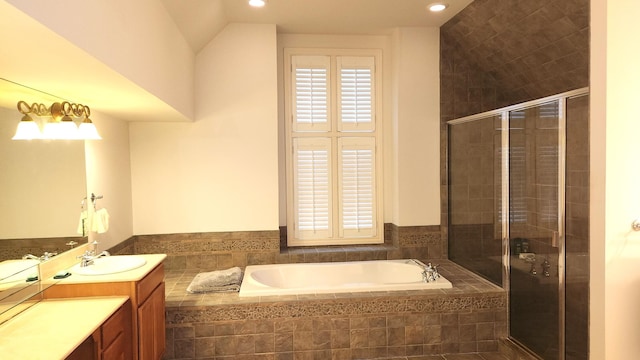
[{"left": 337, "top": 56, "right": 375, "bottom": 131}]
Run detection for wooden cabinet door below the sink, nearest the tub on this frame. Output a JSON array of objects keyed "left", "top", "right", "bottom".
[{"left": 138, "top": 282, "right": 165, "bottom": 360}]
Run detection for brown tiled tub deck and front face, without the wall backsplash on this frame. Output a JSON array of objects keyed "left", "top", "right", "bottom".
[{"left": 165, "top": 260, "right": 507, "bottom": 360}]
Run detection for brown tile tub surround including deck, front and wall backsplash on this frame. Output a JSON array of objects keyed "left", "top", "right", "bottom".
[{"left": 109, "top": 224, "right": 507, "bottom": 360}]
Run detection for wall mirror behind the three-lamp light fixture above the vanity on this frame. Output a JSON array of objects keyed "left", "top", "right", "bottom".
[{"left": 0, "top": 78, "right": 87, "bottom": 270}]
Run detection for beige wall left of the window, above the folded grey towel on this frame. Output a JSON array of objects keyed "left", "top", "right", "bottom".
[{"left": 130, "top": 24, "right": 278, "bottom": 234}]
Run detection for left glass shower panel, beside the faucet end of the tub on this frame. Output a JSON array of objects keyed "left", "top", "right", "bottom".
[{"left": 448, "top": 115, "right": 503, "bottom": 285}]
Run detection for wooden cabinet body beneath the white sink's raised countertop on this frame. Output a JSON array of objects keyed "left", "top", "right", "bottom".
[{"left": 44, "top": 263, "right": 165, "bottom": 360}]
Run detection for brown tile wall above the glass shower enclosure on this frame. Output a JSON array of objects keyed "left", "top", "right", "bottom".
[{"left": 440, "top": 0, "right": 589, "bottom": 256}]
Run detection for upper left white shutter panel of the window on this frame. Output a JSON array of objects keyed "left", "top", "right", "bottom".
[{"left": 291, "top": 56, "right": 331, "bottom": 131}]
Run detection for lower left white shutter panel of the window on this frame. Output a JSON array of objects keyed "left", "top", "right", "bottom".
[{"left": 293, "top": 138, "right": 332, "bottom": 239}]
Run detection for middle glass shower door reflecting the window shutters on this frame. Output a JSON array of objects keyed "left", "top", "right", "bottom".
[{"left": 508, "top": 101, "right": 564, "bottom": 360}]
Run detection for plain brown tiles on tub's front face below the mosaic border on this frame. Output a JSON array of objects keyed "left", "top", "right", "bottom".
[{"left": 165, "top": 310, "right": 506, "bottom": 360}]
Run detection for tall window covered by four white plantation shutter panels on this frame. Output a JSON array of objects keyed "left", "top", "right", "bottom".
[{"left": 285, "top": 49, "right": 383, "bottom": 246}]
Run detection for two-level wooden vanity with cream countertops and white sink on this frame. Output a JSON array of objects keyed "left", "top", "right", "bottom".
[{"left": 0, "top": 250, "right": 166, "bottom": 360}]
